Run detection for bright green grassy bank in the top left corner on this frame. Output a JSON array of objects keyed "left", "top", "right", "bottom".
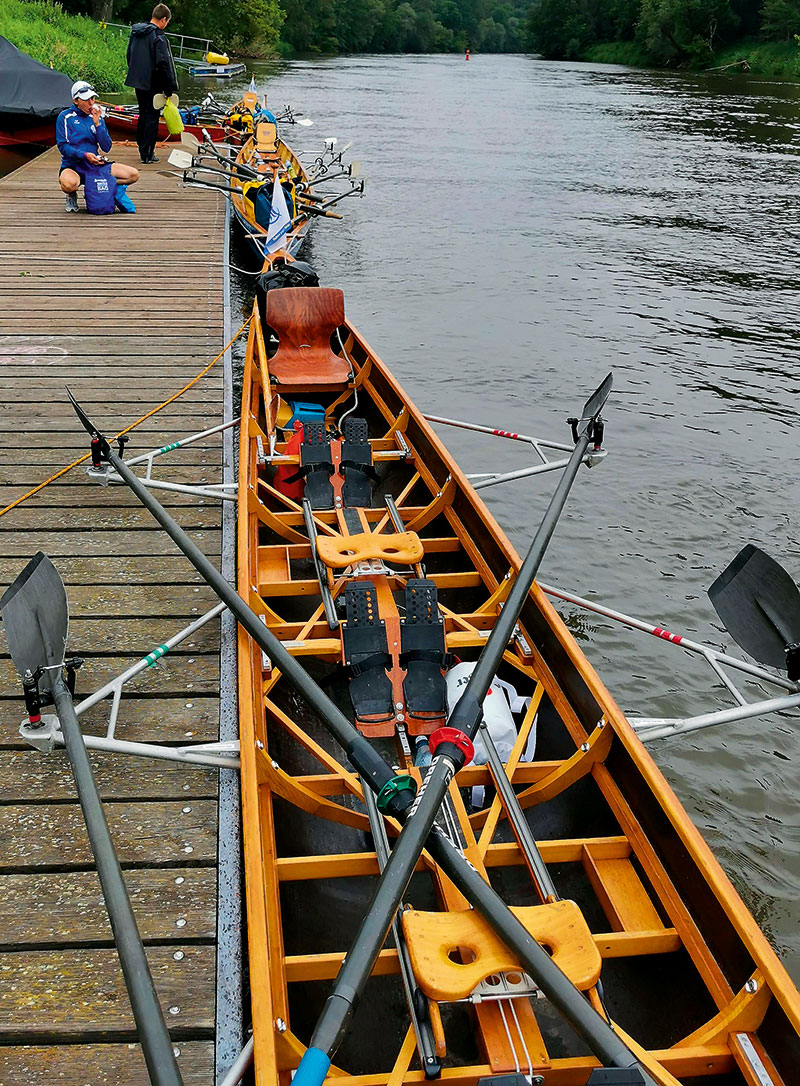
[{"left": 0, "top": 0, "right": 127, "bottom": 93}]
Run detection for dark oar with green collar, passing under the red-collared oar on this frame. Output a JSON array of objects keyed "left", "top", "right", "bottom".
[{"left": 67, "top": 391, "right": 656, "bottom": 1086}]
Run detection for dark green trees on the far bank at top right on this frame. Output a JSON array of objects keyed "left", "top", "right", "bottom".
[{"left": 528, "top": 0, "right": 800, "bottom": 65}]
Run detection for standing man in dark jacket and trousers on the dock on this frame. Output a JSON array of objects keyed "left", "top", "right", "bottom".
[{"left": 125, "top": 3, "right": 178, "bottom": 164}]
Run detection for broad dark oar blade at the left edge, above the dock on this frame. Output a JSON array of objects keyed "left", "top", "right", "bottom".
[{"left": 0, "top": 551, "right": 69, "bottom": 690}]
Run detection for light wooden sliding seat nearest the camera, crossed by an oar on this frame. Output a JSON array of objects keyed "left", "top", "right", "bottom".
[{"left": 403, "top": 901, "right": 602, "bottom": 1002}]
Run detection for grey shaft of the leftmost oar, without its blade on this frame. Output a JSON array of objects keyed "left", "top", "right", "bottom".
[{"left": 53, "top": 674, "right": 182, "bottom": 1086}]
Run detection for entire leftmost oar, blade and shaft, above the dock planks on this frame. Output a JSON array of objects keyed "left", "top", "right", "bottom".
[{"left": 0, "top": 551, "right": 182, "bottom": 1086}]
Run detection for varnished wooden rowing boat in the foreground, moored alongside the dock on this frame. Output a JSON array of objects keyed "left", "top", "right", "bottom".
[{"left": 238, "top": 288, "right": 800, "bottom": 1086}]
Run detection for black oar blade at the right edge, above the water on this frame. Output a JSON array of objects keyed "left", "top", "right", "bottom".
[{"left": 709, "top": 543, "right": 800, "bottom": 670}]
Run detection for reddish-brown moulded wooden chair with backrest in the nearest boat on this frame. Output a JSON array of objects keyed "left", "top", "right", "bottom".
[{"left": 266, "top": 287, "right": 350, "bottom": 391}]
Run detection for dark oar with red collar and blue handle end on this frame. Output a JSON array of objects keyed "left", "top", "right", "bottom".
[{"left": 294, "top": 374, "right": 612, "bottom": 1086}]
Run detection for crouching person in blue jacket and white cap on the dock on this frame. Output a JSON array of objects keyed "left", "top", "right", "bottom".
[{"left": 55, "top": 79, "right": 139, "bottom": 211}]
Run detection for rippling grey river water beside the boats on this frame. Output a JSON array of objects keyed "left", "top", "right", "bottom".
[{"left": 7, "top": 55, "right": 800, "bottom": 980}]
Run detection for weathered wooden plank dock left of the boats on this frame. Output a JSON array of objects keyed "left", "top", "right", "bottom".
[{"left": 0, "top": 147, "right": 233, "bottom": 1086}]
